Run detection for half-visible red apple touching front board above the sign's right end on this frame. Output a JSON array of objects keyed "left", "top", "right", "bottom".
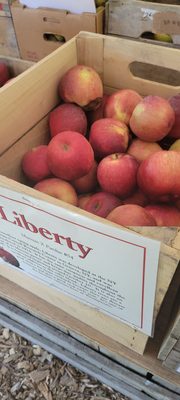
[{"left": 107, "top": 204, "right": 156, "bottom": 226}]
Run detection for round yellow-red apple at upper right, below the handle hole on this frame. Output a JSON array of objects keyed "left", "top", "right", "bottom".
[{"left": 130, "top": 96, "right": 175, "bottom": 142}]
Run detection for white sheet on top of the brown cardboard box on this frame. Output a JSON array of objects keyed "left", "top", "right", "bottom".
[{"left": 20, "top": 0, "right": 96, "bottom": 14}]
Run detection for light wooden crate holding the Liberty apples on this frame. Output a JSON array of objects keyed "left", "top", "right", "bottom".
[{"left": 0, "top": 32, "right": 180, "bottom": 360}]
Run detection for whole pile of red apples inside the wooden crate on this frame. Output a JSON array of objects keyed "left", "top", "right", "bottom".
[{"left": 22, "top": 65, "right": 180, "bottom": 226}]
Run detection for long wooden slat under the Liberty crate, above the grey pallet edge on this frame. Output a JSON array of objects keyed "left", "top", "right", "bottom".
[{"left": 0, "top": 277, "right": 180, "bottom": 390}]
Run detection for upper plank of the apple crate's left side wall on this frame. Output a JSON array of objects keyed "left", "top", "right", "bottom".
[{"left": 0, "top": 39, "right": 77, "bottom": 153}]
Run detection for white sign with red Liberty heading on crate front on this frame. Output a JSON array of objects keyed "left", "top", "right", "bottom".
[{"left": 0, "top": 187, "right": 160, "bottom": 335}]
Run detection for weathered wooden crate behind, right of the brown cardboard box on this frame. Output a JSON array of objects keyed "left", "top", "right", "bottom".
[{"left": 105, "top": 0, "right": 180, "bottom": 45}]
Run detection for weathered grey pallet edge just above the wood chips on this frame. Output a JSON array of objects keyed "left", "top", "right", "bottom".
[{"left": 0, "top": 300, "right": 180, "bottom": 400}]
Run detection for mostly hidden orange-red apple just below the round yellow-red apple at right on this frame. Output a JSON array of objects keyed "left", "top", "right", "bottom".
[{"left": 127, "top": 139, "right": 162, "bottom": 163}]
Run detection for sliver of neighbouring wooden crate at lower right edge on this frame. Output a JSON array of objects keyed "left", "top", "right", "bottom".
[{"left": 158, "top": 291, "right": 180, "bottom": 373}]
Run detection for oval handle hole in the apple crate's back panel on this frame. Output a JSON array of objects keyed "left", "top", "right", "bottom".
[{"left": 129, "top": 61, "right": 180, "bottom": 87}]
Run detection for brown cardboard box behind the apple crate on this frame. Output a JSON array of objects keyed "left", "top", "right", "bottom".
[{"left": 11, "top": 1, "right": 104, "bottom": 61}]
